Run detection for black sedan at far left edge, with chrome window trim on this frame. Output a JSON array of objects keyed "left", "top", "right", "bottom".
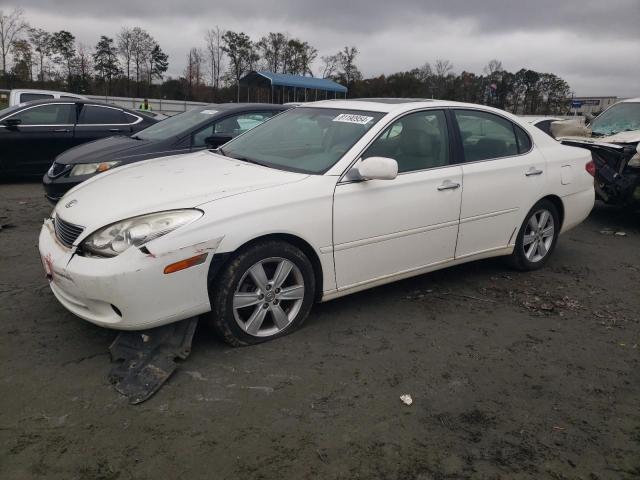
[{"left": 0, "top": 99, "right": 157, "bottom": 178}]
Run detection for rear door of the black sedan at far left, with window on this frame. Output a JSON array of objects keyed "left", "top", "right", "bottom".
[{"left": 75, "top": 104, "right": 133, "bottom": 145}]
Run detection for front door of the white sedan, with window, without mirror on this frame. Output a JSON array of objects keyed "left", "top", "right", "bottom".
[{"left": 333, "top": 110, "right": 462, "bottom": 290}]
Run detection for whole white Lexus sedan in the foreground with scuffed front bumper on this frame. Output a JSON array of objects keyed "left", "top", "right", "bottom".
[{"left": 39, "top": 99, "right": 594, "bottom": 345}]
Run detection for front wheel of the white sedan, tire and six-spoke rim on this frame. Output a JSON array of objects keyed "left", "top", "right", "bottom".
[{"left": 208, "top": 241, "right": 316, "bottom": 346}]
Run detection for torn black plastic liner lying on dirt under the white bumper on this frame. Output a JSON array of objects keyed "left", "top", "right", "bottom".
[{"left": 109, "top": 317, "right": 198, "bottom": 405}]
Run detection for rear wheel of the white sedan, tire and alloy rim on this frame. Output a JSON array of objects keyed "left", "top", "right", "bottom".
[{"left": 509, "top": 199, "right": 560, "bottom": 271}]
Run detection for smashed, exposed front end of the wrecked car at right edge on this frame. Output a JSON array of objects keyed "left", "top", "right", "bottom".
[{"left": 560, "top": 139, "right": 640, "bottom": 207}]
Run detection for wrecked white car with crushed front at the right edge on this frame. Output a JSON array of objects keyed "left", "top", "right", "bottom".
[{"left": 551, "top": 98, "right": 640, "bottom": 208}]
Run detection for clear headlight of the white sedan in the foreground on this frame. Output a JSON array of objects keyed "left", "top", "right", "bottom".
[{"left": 82, "top": 210, "right": 202, "bottom": 257}]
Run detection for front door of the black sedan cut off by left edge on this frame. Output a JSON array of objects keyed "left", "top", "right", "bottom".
[{"left": 0, "top": 102, "right": 75, "bottom": 176}]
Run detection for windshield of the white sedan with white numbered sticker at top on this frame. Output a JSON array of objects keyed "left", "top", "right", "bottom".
[{"left": 221, "top": 107, "right": 385, "bottom": 174}]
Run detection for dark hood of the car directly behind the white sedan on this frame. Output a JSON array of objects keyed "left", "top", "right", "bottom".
[{"left": 56, "top": 136, "right": 171, "bottom": 165}]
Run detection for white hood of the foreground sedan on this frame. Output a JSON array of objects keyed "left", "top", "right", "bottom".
[{"left": 55, "top": 151, "right": 308, "bottom": 233}]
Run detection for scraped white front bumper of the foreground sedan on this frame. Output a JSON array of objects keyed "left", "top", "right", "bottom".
[{"left": 39, "top": 219, "right": 217, "bottom": 330}]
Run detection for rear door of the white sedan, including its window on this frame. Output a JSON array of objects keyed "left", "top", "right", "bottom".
[{"left": 454, "top": 109, "right": 546, "bottom": 258}]
